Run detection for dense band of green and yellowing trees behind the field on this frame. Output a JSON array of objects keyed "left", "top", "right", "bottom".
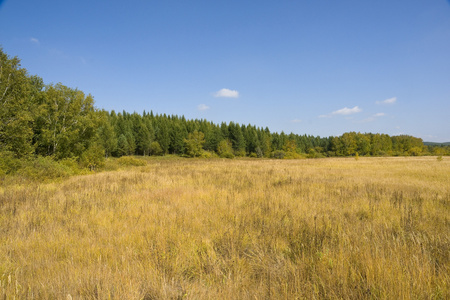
[{"left": 0, "top": 48, "right": 450, "bottom": 173}]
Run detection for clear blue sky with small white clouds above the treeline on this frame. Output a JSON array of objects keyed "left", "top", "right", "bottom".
[{"left": 0, "top": 0, "right": 450, "bottom": 142}]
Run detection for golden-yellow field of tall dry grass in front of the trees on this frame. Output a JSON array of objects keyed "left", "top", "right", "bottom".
[{"left": 0, "top": 157, "right": 450, "bottom": 299}]
